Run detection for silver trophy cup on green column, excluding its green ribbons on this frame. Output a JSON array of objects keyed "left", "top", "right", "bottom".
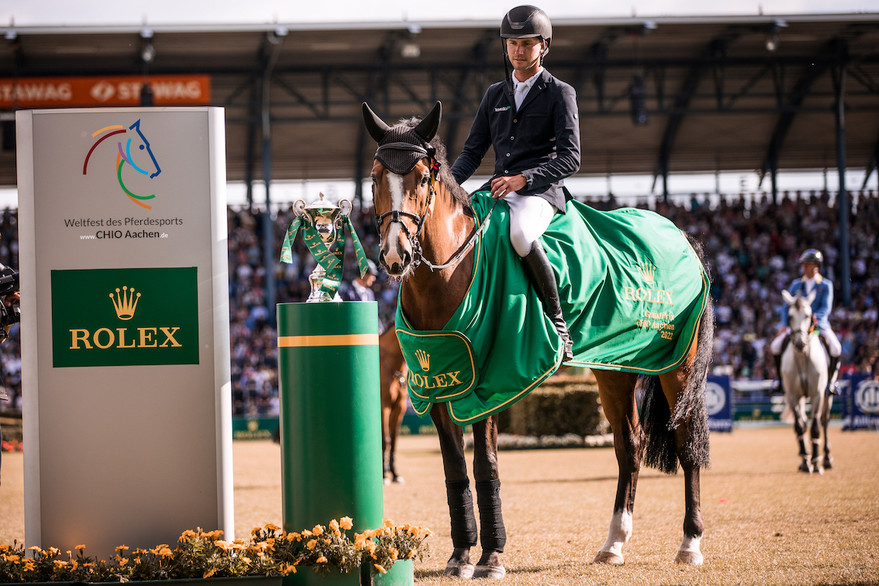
[{"left": 293, "top": 193, "right": 352, "bottom": 303}]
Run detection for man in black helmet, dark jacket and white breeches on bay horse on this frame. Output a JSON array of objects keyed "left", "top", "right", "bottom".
[{"left": 451, "top": 6, "right": 580, "bottom": 360}]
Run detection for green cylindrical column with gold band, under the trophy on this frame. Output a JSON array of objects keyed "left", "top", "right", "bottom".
[{"left": 278, "top": 301, "right": 384, "bottom": 585}]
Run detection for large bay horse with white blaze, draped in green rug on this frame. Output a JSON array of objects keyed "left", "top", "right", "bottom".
[{"left": 362, "top": 102, "right": 714, "bottom": 578}]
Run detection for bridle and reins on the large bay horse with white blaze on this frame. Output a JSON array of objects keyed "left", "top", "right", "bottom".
[{"left": 375, "top": 142, "right": 498, "bottom": 271}]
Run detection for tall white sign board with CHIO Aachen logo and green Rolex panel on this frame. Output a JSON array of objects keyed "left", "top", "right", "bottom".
[{"left": 16, "top": 107, "right": 234, "bottom": 556}]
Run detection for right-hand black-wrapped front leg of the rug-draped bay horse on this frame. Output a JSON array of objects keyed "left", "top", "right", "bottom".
[{"left": 473, "top": 416, "right": 507, "bottom": 579}]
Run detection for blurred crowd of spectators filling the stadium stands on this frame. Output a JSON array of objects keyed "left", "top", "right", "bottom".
[{"left": 0, "top": 190, "right": 879, "bottom": 416}]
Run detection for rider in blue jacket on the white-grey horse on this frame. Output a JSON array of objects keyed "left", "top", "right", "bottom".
[{"left": 769, "top": 248, "right": 842, "bottom": 395}]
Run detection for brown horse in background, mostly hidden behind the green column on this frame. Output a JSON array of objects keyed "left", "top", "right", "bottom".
[{"left": 378, "top": 328, "right": 408, "bottom": 484}]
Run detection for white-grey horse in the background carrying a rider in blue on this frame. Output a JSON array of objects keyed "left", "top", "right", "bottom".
[{"left": 781, "top": 290, "right": 833, "bottom": 474}]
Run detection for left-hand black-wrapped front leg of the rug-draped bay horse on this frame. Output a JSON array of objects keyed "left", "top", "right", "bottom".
[{"left": 430, "top": 403, "right": 477, "bottom": 579}]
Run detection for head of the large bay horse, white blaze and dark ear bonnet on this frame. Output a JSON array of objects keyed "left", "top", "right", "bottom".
[{"left": 363, "top": 102, "right": 442, "bottom": 278}]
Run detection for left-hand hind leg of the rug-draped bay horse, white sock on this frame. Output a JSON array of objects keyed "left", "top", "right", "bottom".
[{"left": 593, "top": 370, "right": 641, "bottom": 564}]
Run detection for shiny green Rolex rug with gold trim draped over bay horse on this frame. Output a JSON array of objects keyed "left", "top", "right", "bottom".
[{"left": 396, "top": 192, "right": 708, "bottom": 425}]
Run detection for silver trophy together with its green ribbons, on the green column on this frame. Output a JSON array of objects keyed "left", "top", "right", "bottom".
[{"left": 281, "top": 193, "right": 368, "bottom": 302}]
